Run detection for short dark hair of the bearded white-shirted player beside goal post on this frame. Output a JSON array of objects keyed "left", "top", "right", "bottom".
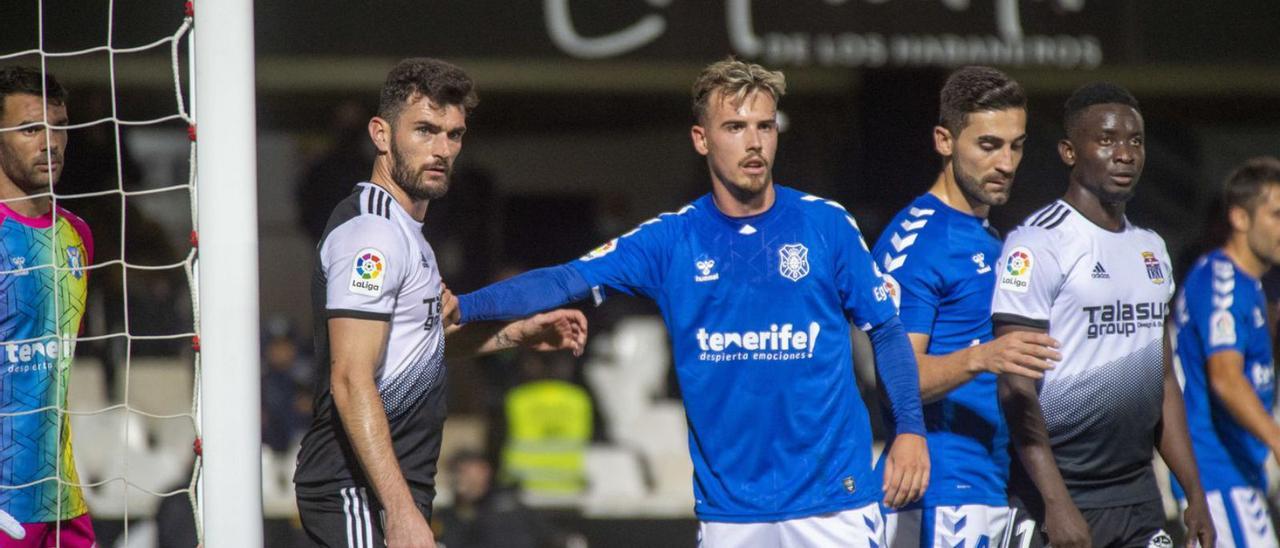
[{"left": 378, "top": 58, "right": 480, "bottom": 124}]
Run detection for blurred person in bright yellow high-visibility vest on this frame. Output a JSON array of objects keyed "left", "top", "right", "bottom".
[{"left": 502, "top": 352, "right": 593, "bottom": 497}]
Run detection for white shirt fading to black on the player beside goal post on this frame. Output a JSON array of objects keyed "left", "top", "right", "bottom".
[{"left": 294, "top": 183, "right": 445, "bottom": 507}]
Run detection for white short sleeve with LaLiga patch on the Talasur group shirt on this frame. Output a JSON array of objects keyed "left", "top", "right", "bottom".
[{"left": 991, "top": 228, "right": 1066, "bottom": 330}]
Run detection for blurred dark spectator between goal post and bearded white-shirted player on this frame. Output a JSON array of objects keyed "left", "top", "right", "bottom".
[{"left": 261, "top": 316, "right": 312, "bottom": 452}]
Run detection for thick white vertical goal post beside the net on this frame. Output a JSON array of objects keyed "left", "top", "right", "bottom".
[{"left": 192, "top": 0, "right": 262, "bottom": 548}]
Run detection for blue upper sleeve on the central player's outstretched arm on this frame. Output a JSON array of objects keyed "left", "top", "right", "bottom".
[{"left": 570, "top": 214, "right": 677, "bottom": 303}]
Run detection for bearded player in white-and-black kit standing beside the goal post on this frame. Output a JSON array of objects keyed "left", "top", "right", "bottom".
[{"left": 294, "top": 59, "right": 586, "bottom": 548}]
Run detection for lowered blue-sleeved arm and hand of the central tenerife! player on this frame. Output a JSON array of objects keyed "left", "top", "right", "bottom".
[{"left": 868, "top": 316, "right": 929, "bottom": 508}]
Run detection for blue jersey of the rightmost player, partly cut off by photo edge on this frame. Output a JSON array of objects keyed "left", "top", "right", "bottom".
[{"left": 1175, "top": 250, "right": 1275, "bottom": 497}]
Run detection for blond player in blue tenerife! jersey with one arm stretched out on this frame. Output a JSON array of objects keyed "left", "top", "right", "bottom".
[{"left": 458, "top": 59, "right": 929, "bottom": 547}]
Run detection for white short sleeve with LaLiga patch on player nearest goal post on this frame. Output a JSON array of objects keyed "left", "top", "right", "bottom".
[{"left": 320, "top": 215, "right": 404, "bottom": 320}]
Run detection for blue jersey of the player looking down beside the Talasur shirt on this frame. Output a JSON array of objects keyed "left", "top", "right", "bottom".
[{"left": 872, "top": 193, "right": 1009, "bottom": 507}]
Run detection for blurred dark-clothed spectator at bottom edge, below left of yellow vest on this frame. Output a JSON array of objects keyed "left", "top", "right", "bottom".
[{"left": 431, "top": 451, "right": 586, "bottom": 548}]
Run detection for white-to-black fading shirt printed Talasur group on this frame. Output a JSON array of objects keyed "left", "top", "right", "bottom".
[{"left": 992, "top": 200, "right": 1174, "bottom": 508}]
